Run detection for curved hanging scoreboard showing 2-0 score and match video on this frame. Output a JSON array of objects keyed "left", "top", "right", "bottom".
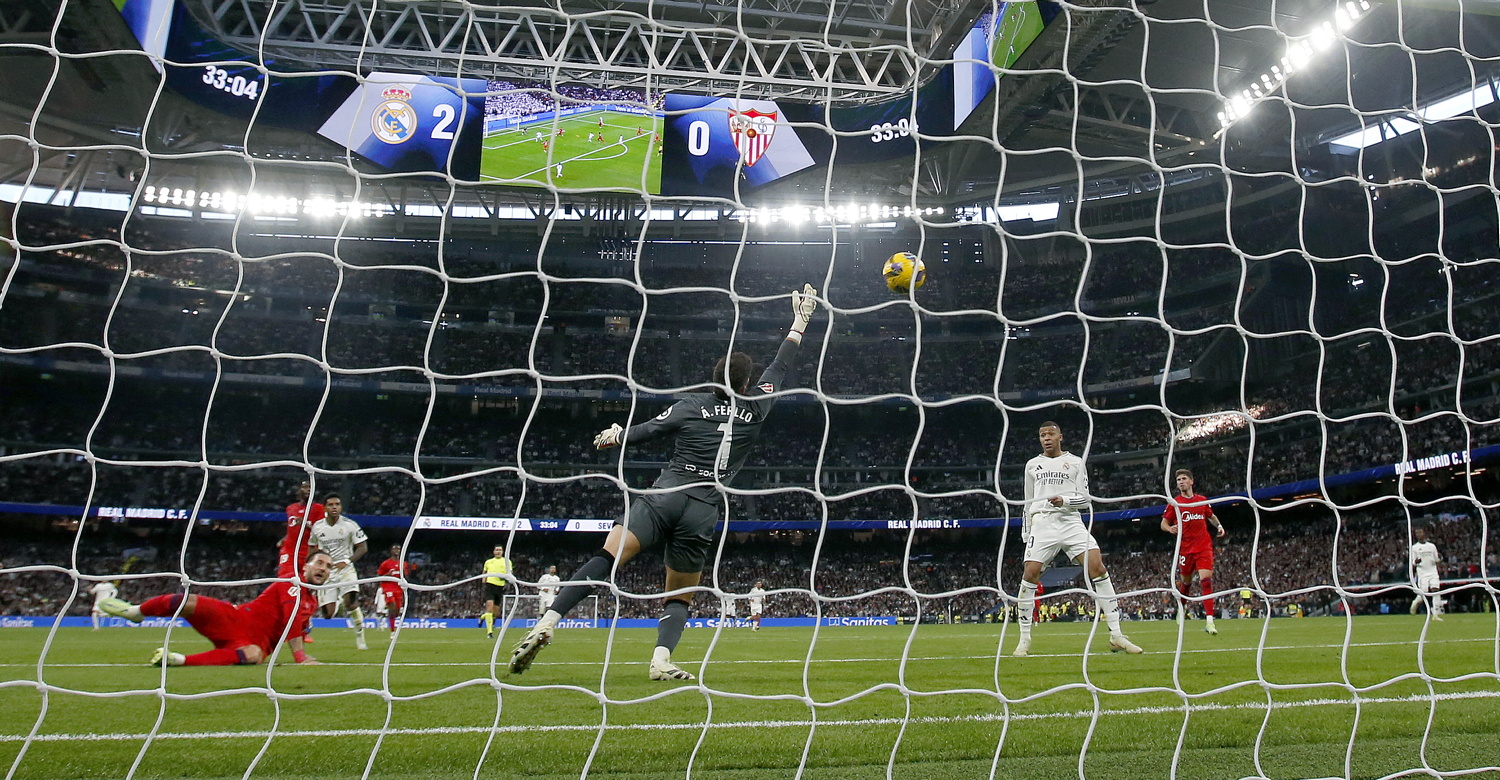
[{"left": 120, "top": 0, "right": 1058, "bottom": 198}]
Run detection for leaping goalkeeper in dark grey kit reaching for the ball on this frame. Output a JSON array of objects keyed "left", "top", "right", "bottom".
[{"left": 510, "top": 285, "right": 818, "bottom": 680}]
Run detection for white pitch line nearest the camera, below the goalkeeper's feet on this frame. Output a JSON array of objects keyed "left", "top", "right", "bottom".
[{"left": 0, "top": 690, "right": 1500, "bottom": 743}]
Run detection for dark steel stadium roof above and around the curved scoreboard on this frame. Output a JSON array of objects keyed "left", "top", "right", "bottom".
[{"left": 0, "top": 0, "right": 1500, "bottom": 225}]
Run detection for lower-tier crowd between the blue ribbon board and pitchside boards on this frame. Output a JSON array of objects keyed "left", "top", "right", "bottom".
[{"left": 0, "top": 503, "right": 1500, "bottom": 621}]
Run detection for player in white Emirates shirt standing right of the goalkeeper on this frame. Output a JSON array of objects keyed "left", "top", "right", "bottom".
[{"left": 1013, "top": 420, "right": 1140, "bottom": 657}]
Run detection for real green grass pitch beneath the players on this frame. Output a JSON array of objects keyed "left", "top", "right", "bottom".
[{"left": 0, "top": 615, "right": 1500, "bottom": 780}]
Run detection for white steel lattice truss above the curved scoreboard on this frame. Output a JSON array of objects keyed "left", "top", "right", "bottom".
[{"left": 191, "top": 0, "right": 987, "bottom": 101}]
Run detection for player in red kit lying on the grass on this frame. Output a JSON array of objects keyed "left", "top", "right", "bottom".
[{"left": 99, "top": 552, "right": 333, "bottom": 666}]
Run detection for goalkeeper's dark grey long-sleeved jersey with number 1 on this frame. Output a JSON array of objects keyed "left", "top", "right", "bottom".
[{"left": 624, "top": 339, "right": 801, "bottom": 504}]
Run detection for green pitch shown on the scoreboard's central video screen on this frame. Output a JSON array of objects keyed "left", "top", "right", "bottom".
[{"left": 480, "top": 111, "right": 662, "bottom": 194}]
